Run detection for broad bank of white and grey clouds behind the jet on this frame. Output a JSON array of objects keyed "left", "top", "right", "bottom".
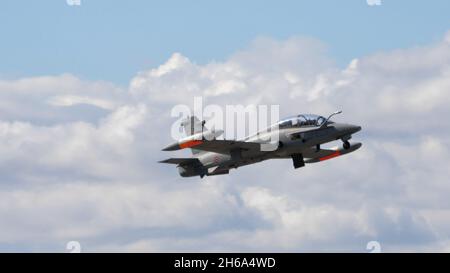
[{"left": 0, "top": 31, "right": 450, "bottom": 251}]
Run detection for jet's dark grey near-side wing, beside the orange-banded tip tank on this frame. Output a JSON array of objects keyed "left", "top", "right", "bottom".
[{"left": 185, "top": 139, "right": 261, "bottom": 154}]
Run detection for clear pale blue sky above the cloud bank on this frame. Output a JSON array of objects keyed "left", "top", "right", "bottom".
[{"left": 0, "top": 0, "right": 450, "bottom": 85}]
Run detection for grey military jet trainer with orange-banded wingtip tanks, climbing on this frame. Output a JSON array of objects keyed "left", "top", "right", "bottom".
[{"left": 160, "top": 111, "right": 361, "bottom": 178}]
